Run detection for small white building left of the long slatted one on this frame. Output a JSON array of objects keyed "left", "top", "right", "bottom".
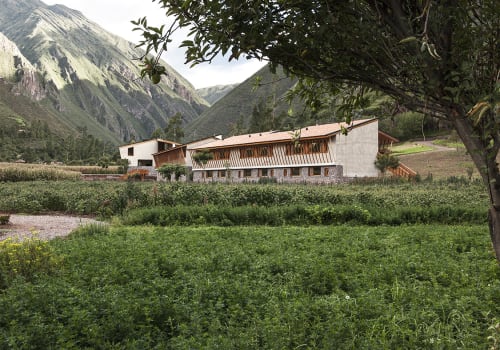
[{"left": 119, "top": 139, "right": 181, "bottom": 170}]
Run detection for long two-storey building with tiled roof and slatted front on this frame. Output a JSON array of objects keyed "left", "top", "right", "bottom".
[{"left": 186, "top": 119, "right": 390, "bottom": 183}]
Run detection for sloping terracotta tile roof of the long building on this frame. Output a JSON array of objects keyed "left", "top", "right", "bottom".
[{"left": 193, "top": 119, "right": 376, "bottom": 149}]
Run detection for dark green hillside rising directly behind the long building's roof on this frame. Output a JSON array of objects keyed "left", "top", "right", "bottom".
[{"left": 184, "top": 66, "right": 296, "bottom": 140}]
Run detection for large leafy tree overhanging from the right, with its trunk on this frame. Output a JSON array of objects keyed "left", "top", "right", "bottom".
[{"left": 134, "top": 0, "right": 500, "bottom": 262}]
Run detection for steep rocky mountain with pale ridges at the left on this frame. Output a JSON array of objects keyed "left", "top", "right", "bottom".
[{"left": 0, "top": 0, "right": 208, "bottom": 144}]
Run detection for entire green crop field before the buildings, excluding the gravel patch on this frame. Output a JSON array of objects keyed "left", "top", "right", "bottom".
[{"left": 0, "top": 179, "right": 500, "bottom": 350}]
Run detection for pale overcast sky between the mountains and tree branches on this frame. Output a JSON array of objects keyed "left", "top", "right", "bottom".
[{"left": 42, "top": 0, "right": 264, "bottom": 89}]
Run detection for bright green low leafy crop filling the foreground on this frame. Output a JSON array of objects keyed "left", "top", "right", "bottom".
[{"left": 0, "top": 225, "right": 500, "bottom": 349}]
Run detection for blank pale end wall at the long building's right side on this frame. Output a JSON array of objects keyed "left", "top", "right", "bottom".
[{"left": 332, "top": 120, "right": 378, "bottom": 177}]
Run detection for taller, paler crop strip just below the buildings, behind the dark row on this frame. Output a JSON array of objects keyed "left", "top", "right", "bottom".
[{"left": 0, "top": 179, "right": 488, "bottom": 217}]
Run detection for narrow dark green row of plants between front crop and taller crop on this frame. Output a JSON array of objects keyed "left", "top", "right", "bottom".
[{"left": 122, "top": 205, "right": 487, "bottom": 226}]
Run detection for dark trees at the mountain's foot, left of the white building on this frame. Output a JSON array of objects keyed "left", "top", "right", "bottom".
[{"left": 0, "top": 118, "right": 119, "bottom": 166}]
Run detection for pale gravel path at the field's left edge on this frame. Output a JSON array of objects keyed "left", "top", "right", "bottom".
[{"left": 0, "top": 214, "right": 102, "bottom": 241}]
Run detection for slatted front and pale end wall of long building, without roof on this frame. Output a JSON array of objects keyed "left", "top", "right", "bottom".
[{"left": 188, "top": 120, "right": 378, "bottom": 183}]
